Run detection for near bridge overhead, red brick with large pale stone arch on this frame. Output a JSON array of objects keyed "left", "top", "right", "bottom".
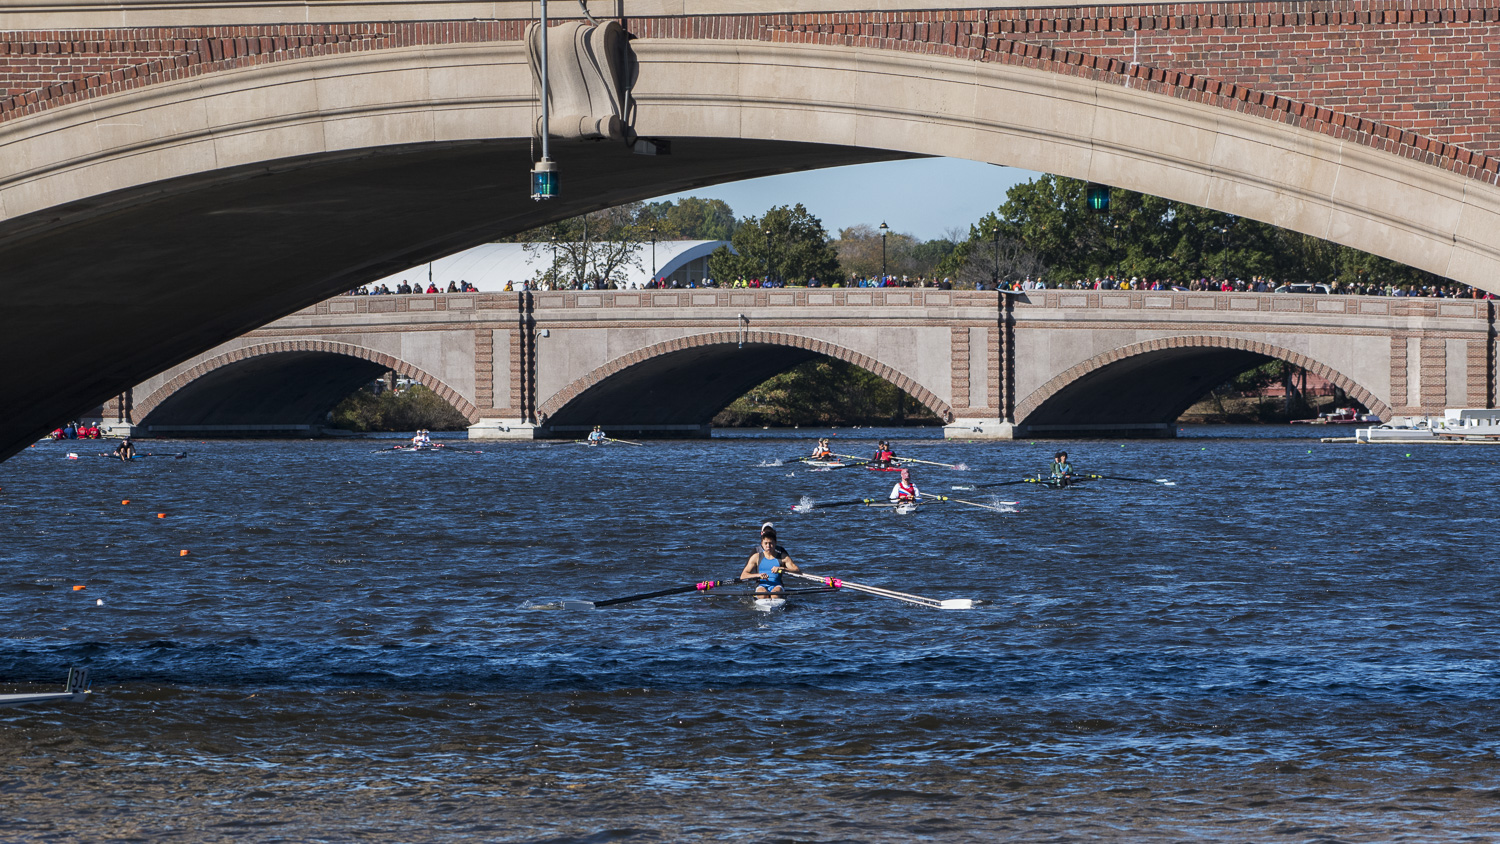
[{"left": 0, "top": 0, "right": 1500, "bottom": 457}]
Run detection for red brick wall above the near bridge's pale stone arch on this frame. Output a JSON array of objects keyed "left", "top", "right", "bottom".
[{"left": 0, "top": 0, "right": 1500, "bottom": 183}]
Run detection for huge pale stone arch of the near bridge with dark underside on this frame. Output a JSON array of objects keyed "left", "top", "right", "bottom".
[{"left": 0, "top": 37, "right": 1500, "bottom": 456}]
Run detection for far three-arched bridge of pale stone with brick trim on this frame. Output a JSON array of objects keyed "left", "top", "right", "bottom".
[{"left": 107, "top": 289, "right": 1496, "bottom": 438}]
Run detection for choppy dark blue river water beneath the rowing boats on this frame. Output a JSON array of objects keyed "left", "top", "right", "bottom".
[{"left": 0, "top": 429, "right": 1500, "bottom": 843}]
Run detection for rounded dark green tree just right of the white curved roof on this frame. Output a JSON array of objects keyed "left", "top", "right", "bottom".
[{"left": 708, "top": 202, "right": 839, "bottom": 283}]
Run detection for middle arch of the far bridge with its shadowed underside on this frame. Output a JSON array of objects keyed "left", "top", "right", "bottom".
[{"left": 539, "top": 330, "right": 954, "bottom": 430}]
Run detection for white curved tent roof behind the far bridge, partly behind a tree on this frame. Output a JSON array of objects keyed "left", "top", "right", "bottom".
[{"left": 369, "top": 240, "right": 732, "bottom": 292}]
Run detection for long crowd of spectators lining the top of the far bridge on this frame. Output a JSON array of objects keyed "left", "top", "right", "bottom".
[{"left": 347, "top": 276, "right": 1496, "bottom": 298}]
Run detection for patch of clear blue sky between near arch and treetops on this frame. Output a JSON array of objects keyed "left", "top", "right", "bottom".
[{"left": 662, "top": 159, "right": 1041, "bottom": 240}]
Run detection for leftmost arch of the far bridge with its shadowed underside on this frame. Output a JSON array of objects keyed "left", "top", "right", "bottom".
[{"left": 132, "top": 339, "right": 479, "bottom": 427}]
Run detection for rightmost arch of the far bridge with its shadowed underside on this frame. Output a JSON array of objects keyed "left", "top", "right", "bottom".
[{"left": 1016, "top": 336, "right": 1391, "bottom": 435}]
